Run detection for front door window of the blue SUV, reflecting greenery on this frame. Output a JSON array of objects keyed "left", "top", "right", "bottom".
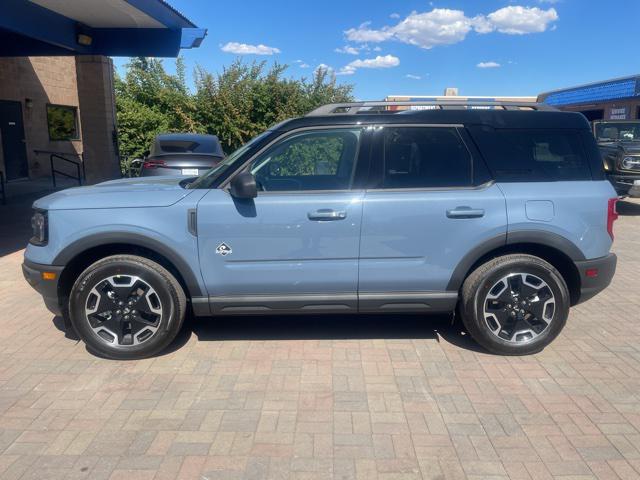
[{"left": 250, "top": 128, "right": 360, "bottom": 192}]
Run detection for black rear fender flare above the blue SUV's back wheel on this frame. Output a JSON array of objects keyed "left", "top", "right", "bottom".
[{"left": 447, "top": 230, "right": 585, "bottom": 291}]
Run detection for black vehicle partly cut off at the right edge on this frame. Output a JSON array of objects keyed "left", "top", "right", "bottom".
[{"left": 593, "top": 120, "right": 640, "bottom": 197}]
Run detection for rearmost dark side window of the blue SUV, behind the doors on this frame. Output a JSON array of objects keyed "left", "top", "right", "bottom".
[{"left": 471, "top": 128, "right": 591, "bottom": 182}]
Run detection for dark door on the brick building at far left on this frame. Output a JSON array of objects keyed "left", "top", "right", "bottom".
[{"left": 0, "top": 100, "right": 29, "bottom": 180}]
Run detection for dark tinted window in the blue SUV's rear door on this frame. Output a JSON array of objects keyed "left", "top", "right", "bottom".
[{"left": 382, "top": 127, "right": 472, "bottom": 188}]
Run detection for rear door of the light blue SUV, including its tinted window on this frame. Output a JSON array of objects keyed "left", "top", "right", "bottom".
[{"left": 358, "top": 125, "right": 507, "bottom": 311}]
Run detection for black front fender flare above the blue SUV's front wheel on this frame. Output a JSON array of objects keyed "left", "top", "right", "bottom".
[{"left": 53, "top": 232, "right": 203, "bottom": 297}]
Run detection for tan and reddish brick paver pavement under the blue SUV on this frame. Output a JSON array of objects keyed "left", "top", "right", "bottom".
[{"left": 0, "top": 202, "right": 640, "bottom": 480}]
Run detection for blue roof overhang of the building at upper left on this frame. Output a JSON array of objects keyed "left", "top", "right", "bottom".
[{"left": 0, "top": 0, "right": 207, "bottom": 57}]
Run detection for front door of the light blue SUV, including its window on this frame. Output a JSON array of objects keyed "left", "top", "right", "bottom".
[{"left": 197, "top": 128, "right": 366, "bottom": 314}]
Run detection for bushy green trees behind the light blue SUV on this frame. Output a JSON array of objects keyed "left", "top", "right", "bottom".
[{"left": 115, "top": 58, "right": 353, "bottom": 170}]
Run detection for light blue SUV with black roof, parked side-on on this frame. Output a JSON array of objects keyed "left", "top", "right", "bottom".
[{"left": 23, "top": 102, "right": 617, "bottom": 358}]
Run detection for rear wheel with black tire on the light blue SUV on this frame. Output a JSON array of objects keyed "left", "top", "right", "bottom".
[{"left": 460, "top": 254, "right": 570, "bottom": 355}]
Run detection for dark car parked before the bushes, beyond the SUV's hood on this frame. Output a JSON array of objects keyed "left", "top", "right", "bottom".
[{"left": 140, "top": 133, "right": 224, "bottom": 177}]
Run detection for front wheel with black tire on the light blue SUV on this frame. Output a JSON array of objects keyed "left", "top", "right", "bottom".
[{"left": 69, "top": 255, "right": 187, "bottom": 360}]
